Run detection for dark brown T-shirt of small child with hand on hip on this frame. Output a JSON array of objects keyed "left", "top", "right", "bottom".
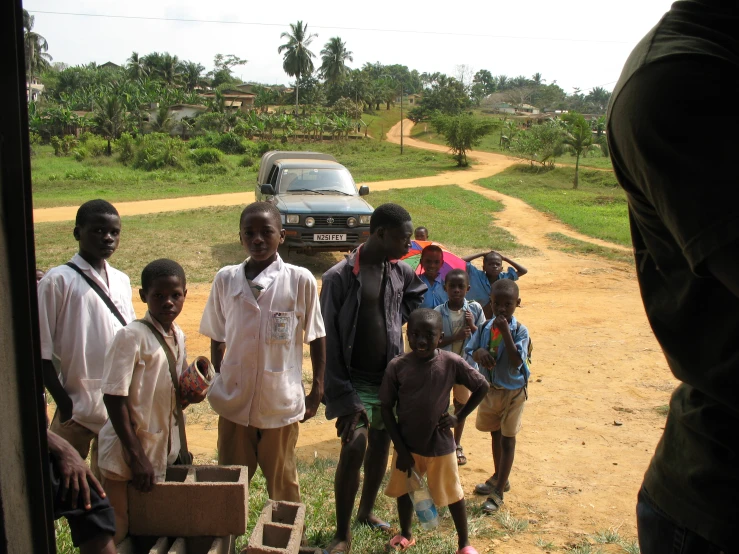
[{"left": 380, "top": 348, "right": 487, "bottom": 456}]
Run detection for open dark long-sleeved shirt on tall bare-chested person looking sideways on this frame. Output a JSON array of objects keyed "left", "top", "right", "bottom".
[{"left": 321, "top": 247, "right": 426, "bottom": 419}]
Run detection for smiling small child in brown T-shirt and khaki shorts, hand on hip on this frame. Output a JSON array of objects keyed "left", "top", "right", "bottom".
[{"left": 380, "top": 308, "right": 488, "bottom": 554}]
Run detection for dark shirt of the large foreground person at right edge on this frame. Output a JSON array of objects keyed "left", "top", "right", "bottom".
[{"left": 608, "top": 0, "right": 739, "bottom": 551}]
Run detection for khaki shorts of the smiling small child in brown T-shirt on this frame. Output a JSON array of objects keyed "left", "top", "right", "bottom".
[{"left": 385, "top": 449, "right": 464, "bottom": 508}]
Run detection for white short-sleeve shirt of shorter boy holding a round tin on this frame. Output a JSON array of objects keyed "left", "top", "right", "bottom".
[{"left": 98, "top": 312, "right": 187, "bottom": 481}]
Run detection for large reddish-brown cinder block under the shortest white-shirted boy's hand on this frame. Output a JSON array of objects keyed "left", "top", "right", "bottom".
[{"left": 128, "top": 466, "right": 249, "bottom": 536}]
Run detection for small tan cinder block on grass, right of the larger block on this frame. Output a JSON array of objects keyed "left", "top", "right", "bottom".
[{"left": 247, "top": 500, "right": 305, "bottom": 554}]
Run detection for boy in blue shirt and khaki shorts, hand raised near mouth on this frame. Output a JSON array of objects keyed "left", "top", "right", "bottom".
[{"left": 465, "top": 279, "right": 530, "bottom": 513}]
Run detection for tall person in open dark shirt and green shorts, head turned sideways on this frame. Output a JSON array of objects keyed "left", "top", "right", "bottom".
[{"left": 321, "top": 204, "right": 426, "bottom": 554}]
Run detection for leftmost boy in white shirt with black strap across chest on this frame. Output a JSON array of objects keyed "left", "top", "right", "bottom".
[{"left": 38, "top": 200, "right": 136, "bottom": 475}]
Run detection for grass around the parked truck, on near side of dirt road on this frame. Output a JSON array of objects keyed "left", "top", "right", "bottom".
[{"left": 35, "top": 186, "right": 518, "bottom": 284}]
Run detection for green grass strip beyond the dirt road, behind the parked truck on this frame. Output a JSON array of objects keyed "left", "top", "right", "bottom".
[{"left": 31, "top": 139, "right": 455, "bottom": 208}]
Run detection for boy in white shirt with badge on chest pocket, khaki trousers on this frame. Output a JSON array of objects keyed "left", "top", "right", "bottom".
[{"left": 200, "top": 202, "right": 326, "bottom": 502}]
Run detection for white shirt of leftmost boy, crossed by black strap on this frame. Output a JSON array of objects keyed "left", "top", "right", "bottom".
[{"left": 38, "top": 254, "right": 136, "bottom": 433}]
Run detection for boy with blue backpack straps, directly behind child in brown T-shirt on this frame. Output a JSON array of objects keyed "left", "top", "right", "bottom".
[{"left": 434, "top": 269, "right": 485, "bottom": 466}]
